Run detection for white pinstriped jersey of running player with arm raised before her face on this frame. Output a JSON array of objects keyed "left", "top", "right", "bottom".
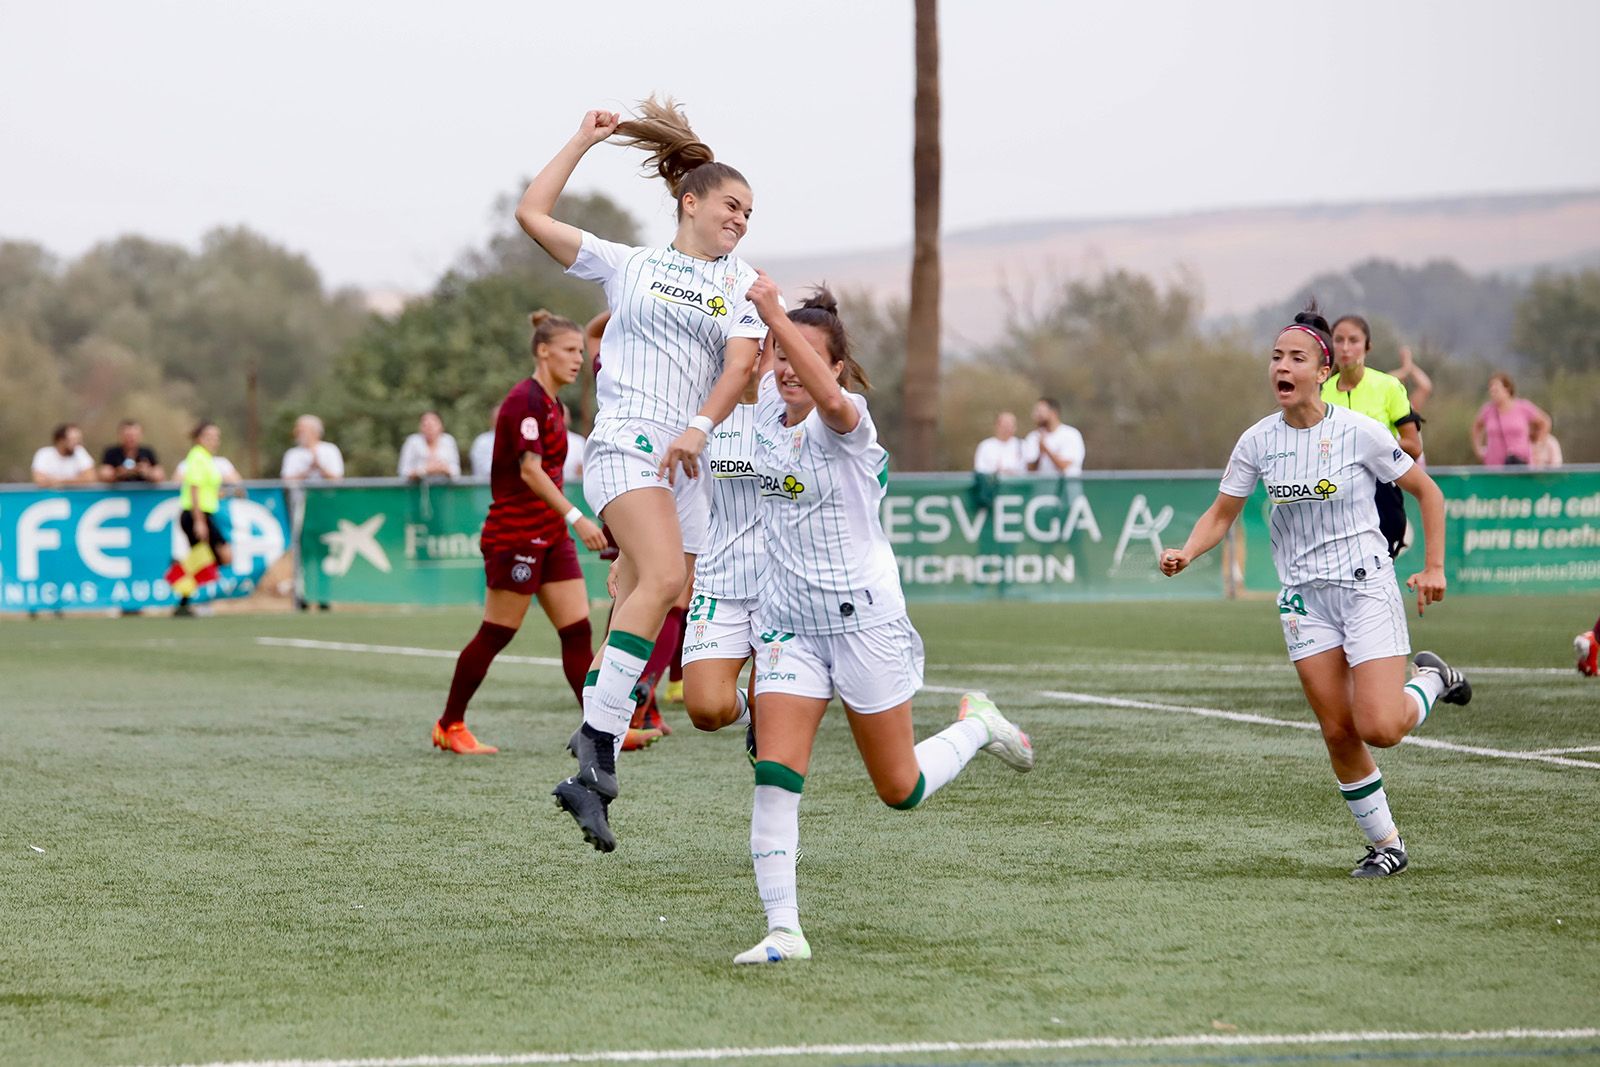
[{"left": 755, "top": 374, "right": 906, "bottom": 633}]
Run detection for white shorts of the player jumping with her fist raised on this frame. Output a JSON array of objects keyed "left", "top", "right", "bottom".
[{"left": 584, "top": 418, "right": 710, "bottom": 555}]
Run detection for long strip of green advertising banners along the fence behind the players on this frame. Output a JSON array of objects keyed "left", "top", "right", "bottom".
[{"left": 291, "top": 469, "right": 1600, "bottom": 605}]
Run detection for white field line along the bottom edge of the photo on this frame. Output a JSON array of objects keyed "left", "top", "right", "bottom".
[{"left": 131, "top": 1029, "right": 1600, "bottom": 1067}]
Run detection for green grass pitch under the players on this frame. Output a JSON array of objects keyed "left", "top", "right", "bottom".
[{"left": 0, "top": 598, "right": 1600, "bottom": 1064}]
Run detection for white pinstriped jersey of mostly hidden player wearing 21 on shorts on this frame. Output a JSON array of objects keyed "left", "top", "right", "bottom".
[{"left": 694, "top": 403, "right": 766, "bottom": 600}]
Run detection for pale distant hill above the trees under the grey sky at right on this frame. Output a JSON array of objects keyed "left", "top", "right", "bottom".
[{"left": 762, "top": 190, "right": 1600, "bottom": 346}]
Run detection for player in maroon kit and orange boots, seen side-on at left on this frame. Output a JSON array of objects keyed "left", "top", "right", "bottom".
[{"left": 434, "top": 310, "right": 606, "bottom": 755}]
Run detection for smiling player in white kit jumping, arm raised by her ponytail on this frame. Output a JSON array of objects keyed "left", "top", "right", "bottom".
[{"left": 517, "top": 98, "right": 766, "bottom": 851}]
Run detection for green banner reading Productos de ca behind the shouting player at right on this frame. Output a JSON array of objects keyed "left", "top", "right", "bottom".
[{"left": 1245, "top": 467, "right": 1600, "bottom": 595}]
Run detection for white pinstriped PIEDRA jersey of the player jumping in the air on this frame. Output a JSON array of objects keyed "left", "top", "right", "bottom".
[{"left": 566, "top": 234, "right": 766, "bottom": 429}]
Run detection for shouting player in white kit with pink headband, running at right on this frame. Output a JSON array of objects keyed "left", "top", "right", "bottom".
[{"left": 1160, "top": 306, "right": 1472, "bottom": 878}]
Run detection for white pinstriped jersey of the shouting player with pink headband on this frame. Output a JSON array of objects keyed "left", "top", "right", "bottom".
[{"left": 1221, "top": 405, "right": 1411, "bottom": 585}]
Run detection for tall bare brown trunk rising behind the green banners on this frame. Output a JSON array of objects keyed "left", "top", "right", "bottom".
[{"left": 901, "top": 0, "right": 941, "bottom": 470}]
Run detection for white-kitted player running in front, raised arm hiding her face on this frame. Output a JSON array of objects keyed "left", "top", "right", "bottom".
[{"left": 733, "top": 275, "right": 1034, "bottom": 963}]
